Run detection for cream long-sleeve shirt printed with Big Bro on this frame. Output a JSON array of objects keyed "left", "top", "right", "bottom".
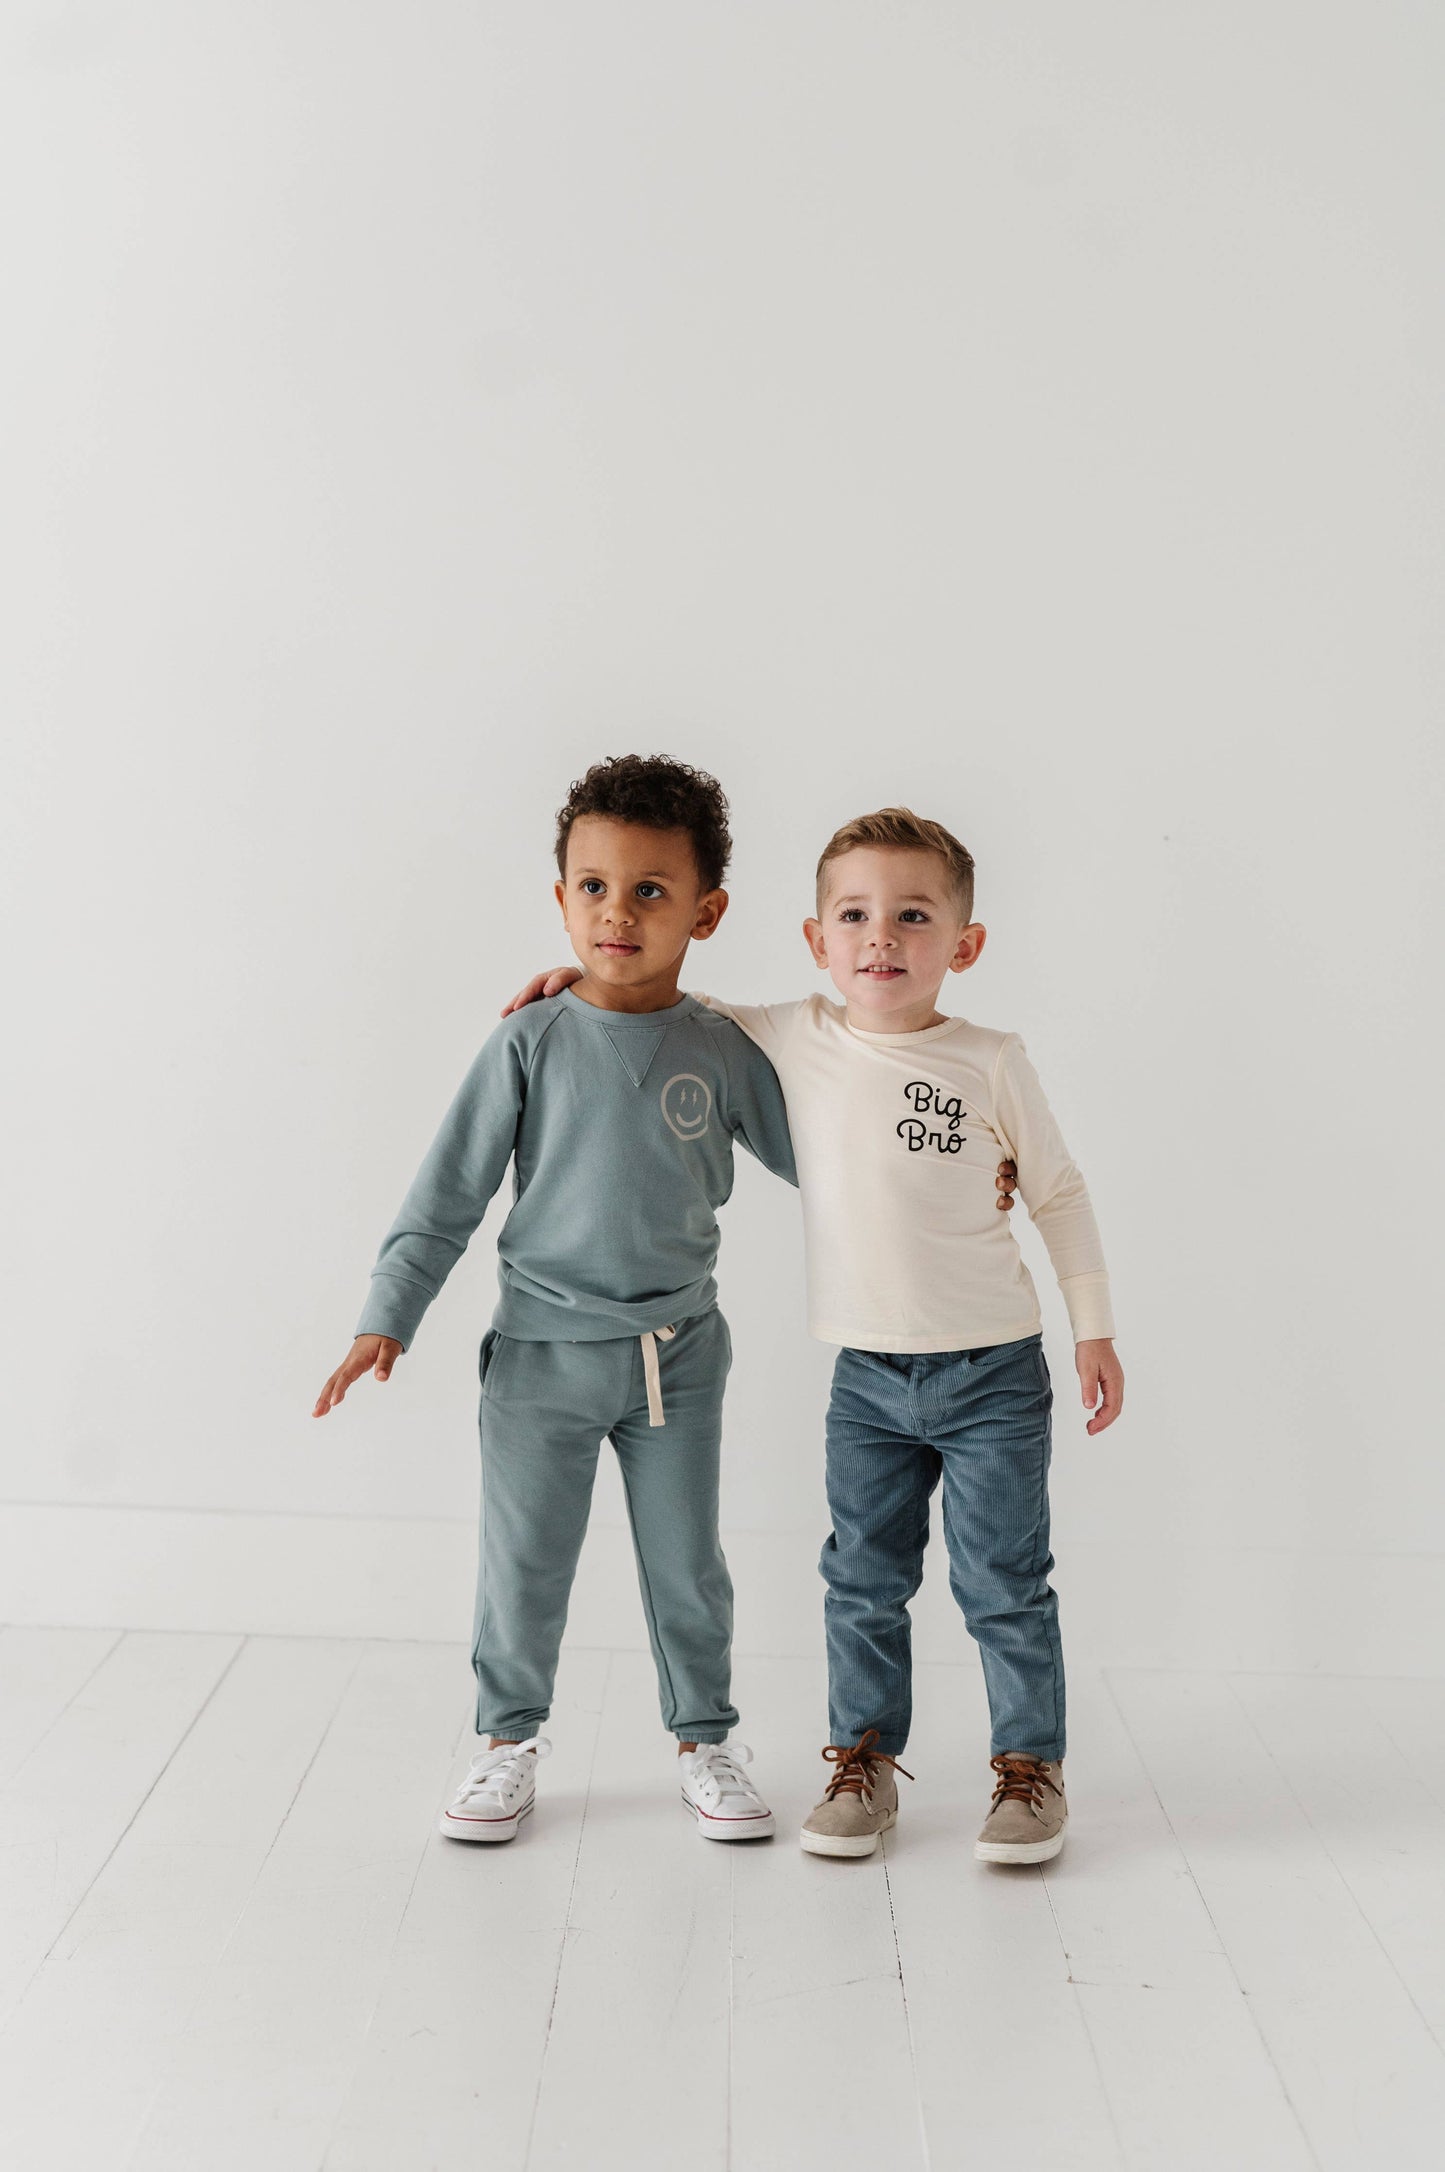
[{"left": 704, "top": 995, "right": 1115, "bottom": 1351}]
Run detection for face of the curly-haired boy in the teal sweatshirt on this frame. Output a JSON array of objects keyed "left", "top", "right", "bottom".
[{"left": 556, "top": 815, "right": 728, "bottom": 997}]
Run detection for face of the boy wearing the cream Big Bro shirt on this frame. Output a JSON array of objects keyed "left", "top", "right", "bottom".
[{"left": 804, "top": 845, "right": 984, "bottom": 1032}]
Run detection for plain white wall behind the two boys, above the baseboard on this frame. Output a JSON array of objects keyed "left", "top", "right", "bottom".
[{"left": 0, "top": 0, "right": 1445, "bottom": 1642}]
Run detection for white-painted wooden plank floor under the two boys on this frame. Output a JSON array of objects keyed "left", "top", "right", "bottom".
[{"left": 0, "top": 1627, "right": 1445, "bottom": 2172}]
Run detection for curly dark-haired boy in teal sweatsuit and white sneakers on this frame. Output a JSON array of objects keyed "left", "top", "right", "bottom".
[{"left": 315, "top": 754, "right": 797, "bottom": 1842}]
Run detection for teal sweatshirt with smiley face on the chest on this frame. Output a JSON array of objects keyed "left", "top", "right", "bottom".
[{"left": 356, "top": 990, "right": 797, "bottom": 1347}]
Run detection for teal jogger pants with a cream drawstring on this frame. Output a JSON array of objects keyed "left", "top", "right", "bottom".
[{"left": 472, "top": 1312, "right": 737, "bottom": 1742}]
